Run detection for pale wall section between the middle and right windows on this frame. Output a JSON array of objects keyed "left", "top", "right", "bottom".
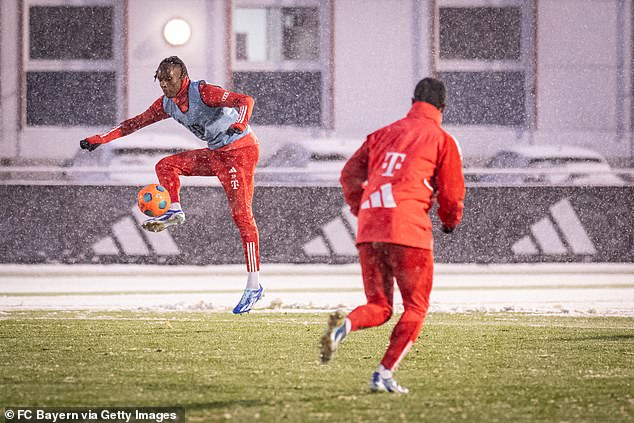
[{"left": 334, "top": 0, "right": 414, "bottom": 137}]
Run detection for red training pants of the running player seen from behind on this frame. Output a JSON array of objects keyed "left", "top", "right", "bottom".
[{"left": 347, "top": 242, "right": 434, "bottom": 370}]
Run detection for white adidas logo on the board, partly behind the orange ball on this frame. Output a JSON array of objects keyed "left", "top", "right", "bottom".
[{"left": 92, "top": 207, "right": 180, "bottom": 256}]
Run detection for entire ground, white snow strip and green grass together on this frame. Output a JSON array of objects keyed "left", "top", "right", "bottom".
[{"left": 0, "top": 265, "right": 634, "bottom": 422}]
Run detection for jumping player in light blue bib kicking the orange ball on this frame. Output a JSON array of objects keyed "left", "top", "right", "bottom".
[{"left": 79, "top": 56, "right": 264, "bottom": 314}]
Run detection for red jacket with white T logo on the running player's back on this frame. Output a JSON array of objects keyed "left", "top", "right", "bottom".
[{"left": 340, "top": 102, "right": 465, "bottom": 249}]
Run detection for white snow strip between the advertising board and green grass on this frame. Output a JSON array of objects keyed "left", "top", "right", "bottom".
[{"left": 0, "top": 263, "right": 634, "bottom": 316}]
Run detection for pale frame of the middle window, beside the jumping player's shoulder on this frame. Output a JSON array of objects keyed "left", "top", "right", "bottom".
[{"left": 229, "top": 0, "right": 334, "bottom": 129}]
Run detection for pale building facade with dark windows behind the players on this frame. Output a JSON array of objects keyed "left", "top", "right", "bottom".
[{"left": 0, "top": 0, "right": 634, "bottom": 164}]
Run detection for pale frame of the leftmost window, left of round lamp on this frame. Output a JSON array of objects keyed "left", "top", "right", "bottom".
[{"left": 19, "top": 0, "right": 127, "bottom": 131}]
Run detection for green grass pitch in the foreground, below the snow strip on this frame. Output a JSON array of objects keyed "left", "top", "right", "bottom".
[{"left": 0, "top": 312, "right": 634, "bottom": 422}]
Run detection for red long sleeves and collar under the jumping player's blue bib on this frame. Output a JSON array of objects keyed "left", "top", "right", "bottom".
[{"left": 88, "top": 77, "right": 254, "bottom": 144}]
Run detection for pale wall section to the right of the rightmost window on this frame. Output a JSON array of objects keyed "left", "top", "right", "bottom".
[{"left": 536, "top": 0, "right": 632, "bottom": 156}]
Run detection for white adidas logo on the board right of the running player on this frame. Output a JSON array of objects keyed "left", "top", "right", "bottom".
[{"left": 511, "top": 198, "right": 597, "bottom": 256}]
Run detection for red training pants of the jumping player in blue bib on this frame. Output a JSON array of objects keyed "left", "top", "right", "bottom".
[{"left": 156, "top": 134, "right": 260, "bottom": 272}]
